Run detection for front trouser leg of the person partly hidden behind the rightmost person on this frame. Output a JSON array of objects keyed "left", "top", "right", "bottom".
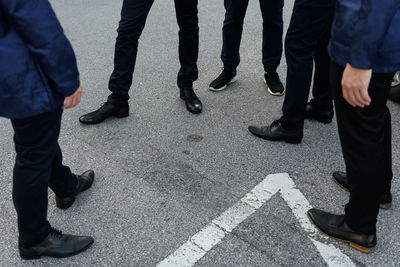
[{"left": 280, "top": 0, "right": 334, "bottom": 130}]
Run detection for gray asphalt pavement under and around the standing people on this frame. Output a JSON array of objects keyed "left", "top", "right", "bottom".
[{"left": 0, "top": 0, "right": 400, "bottom": 266}]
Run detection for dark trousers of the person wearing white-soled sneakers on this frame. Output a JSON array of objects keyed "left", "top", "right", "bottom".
[{"left": 221, "top": 0, "right": 284, "bottom": 72}]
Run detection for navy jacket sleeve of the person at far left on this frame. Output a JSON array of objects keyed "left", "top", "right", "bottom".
[{"left": 0, "top": 0, "right": 79, "bottom": 96}]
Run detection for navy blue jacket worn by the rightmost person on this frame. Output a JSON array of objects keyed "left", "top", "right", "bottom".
[{"left": 329, "top": 0, "right": 400, "bottom": 73}]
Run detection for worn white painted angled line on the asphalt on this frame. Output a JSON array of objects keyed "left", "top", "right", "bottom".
[{"left": 157, "top": 173, "right": 355, "bottom": 267}]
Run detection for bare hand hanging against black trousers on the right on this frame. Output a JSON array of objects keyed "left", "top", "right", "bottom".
[{"left": 342, "top": 64, "right": 372, "bottom": 108}]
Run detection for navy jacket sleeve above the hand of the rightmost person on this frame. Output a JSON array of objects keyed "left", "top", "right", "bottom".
[{"left": 348, "top": 0, "right": 400, "bottom": 69}]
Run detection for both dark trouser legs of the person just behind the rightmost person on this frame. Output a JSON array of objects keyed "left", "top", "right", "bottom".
[{"left": 280, "top": 0, "right": 335, "bottom": 130}]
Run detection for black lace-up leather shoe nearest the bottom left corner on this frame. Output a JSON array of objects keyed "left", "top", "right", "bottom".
[{"left": 19, "top": 229, "right": 94, "bottom": 260}]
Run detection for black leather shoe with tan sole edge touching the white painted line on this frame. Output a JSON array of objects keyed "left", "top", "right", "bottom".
[{"left": 307, "top": 209, "right": 376, "bottom": 253}]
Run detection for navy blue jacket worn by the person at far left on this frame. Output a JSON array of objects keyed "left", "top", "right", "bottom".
[{"left": 0, "top": 0, "right": 79, "bottom": 119}]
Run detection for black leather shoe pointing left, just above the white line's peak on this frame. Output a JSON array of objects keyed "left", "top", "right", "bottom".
[{"left": 248, "top": 120, "right": 303, "bottom": 144}]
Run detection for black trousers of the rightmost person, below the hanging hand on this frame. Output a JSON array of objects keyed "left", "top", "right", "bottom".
[{"left": 331, "top": 63, "right": 394, "bottom": 234}]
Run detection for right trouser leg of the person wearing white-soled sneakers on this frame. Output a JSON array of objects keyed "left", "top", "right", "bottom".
[{"left": 260, "top": 0, "right": 284, "bottom": 73}]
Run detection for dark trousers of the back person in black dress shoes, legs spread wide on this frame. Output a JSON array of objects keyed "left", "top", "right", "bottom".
[{"left": 108, "top": 0, "right": 199, "bottom": 105}]
